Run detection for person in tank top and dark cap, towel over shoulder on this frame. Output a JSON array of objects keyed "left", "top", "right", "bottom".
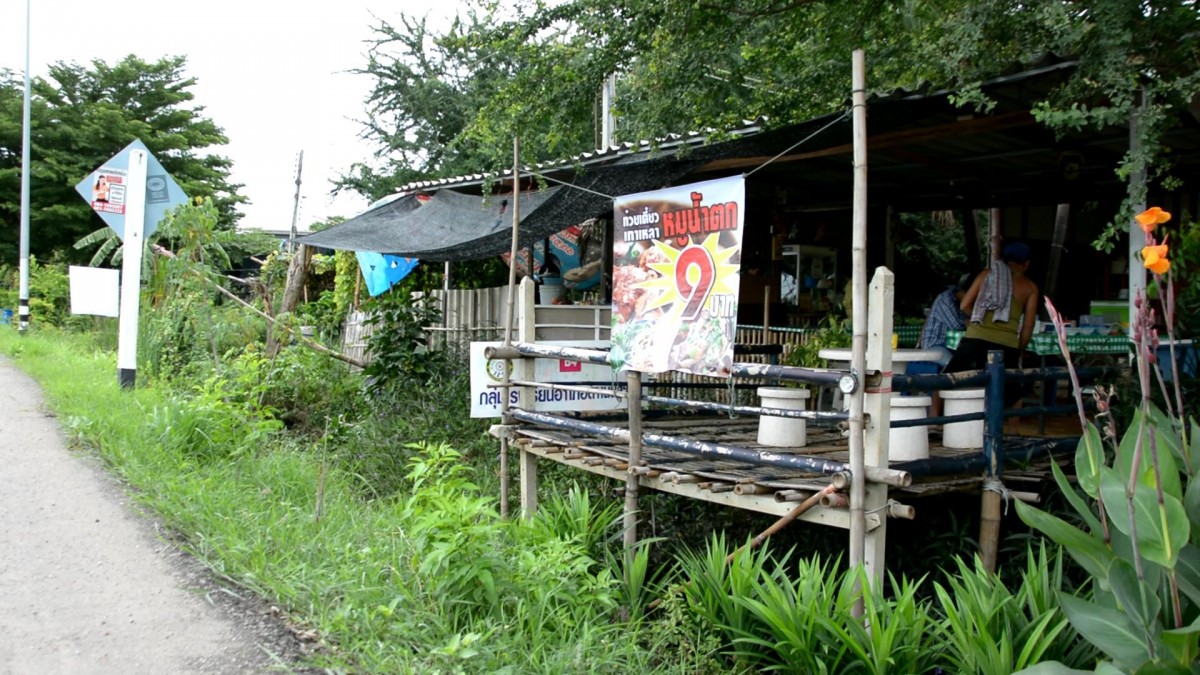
[{"left": 946, "top": 243, "right": 1038, "bottom": 407}]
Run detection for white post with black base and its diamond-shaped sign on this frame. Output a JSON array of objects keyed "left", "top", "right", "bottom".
[{"left": 76, "top": 141, "right": 187, "bottom": 389}]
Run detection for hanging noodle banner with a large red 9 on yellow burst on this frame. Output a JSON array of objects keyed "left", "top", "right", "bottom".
[{"left": 612, "top": 177, "right": 745, "bottom": 377}]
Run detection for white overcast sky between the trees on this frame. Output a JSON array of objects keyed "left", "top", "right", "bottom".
[{"left": 0, "top": 0, "right": 458, "bottom": 229}]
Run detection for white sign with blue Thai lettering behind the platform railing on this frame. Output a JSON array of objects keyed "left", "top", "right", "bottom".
[{"left": 470, "top": 340, "right": 626, "bottom": 417}]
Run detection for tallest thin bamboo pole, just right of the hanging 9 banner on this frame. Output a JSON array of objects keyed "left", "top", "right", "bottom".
[{"left": 850, "top": 49, "right": 866, "bottom": 605}]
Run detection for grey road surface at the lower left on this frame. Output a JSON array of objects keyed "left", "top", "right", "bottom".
[{"left": 0, "top": 357, "right": 314, "bottom": 675}]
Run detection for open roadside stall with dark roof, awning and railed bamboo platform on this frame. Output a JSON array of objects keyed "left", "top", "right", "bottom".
[{"left": 300, "top": 53, "right": 1200, "bottom": 578}]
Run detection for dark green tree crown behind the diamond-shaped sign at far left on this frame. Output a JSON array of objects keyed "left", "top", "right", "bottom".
[{"left": 0, "top": 55, "right": 246, "bottom": 261}]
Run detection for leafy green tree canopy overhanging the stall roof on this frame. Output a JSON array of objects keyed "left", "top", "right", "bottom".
[{"left": 343, "top": 0, "right": 1200, "bottom": 212}]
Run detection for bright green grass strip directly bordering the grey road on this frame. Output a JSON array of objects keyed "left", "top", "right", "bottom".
[{"left": 0, "top": 329, "right": 672, "bottom": 673}]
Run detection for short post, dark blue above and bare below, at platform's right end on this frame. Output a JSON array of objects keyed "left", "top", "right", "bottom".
[{"left": 979, "top": 350, "right": 1004, "bottom": 572}]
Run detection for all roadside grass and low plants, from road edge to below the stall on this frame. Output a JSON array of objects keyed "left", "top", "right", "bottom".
[{"left": 0, "top": 327, "right": 1094, "bottom": 675}]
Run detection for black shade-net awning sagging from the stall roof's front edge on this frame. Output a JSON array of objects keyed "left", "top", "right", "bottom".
[{"left": 296, "top": 157, "right": 701, "bottom": 262}]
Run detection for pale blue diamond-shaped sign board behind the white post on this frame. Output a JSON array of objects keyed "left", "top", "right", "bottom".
[{"left": 76, "top": 141, "right": 187, "bottom": 241}]
